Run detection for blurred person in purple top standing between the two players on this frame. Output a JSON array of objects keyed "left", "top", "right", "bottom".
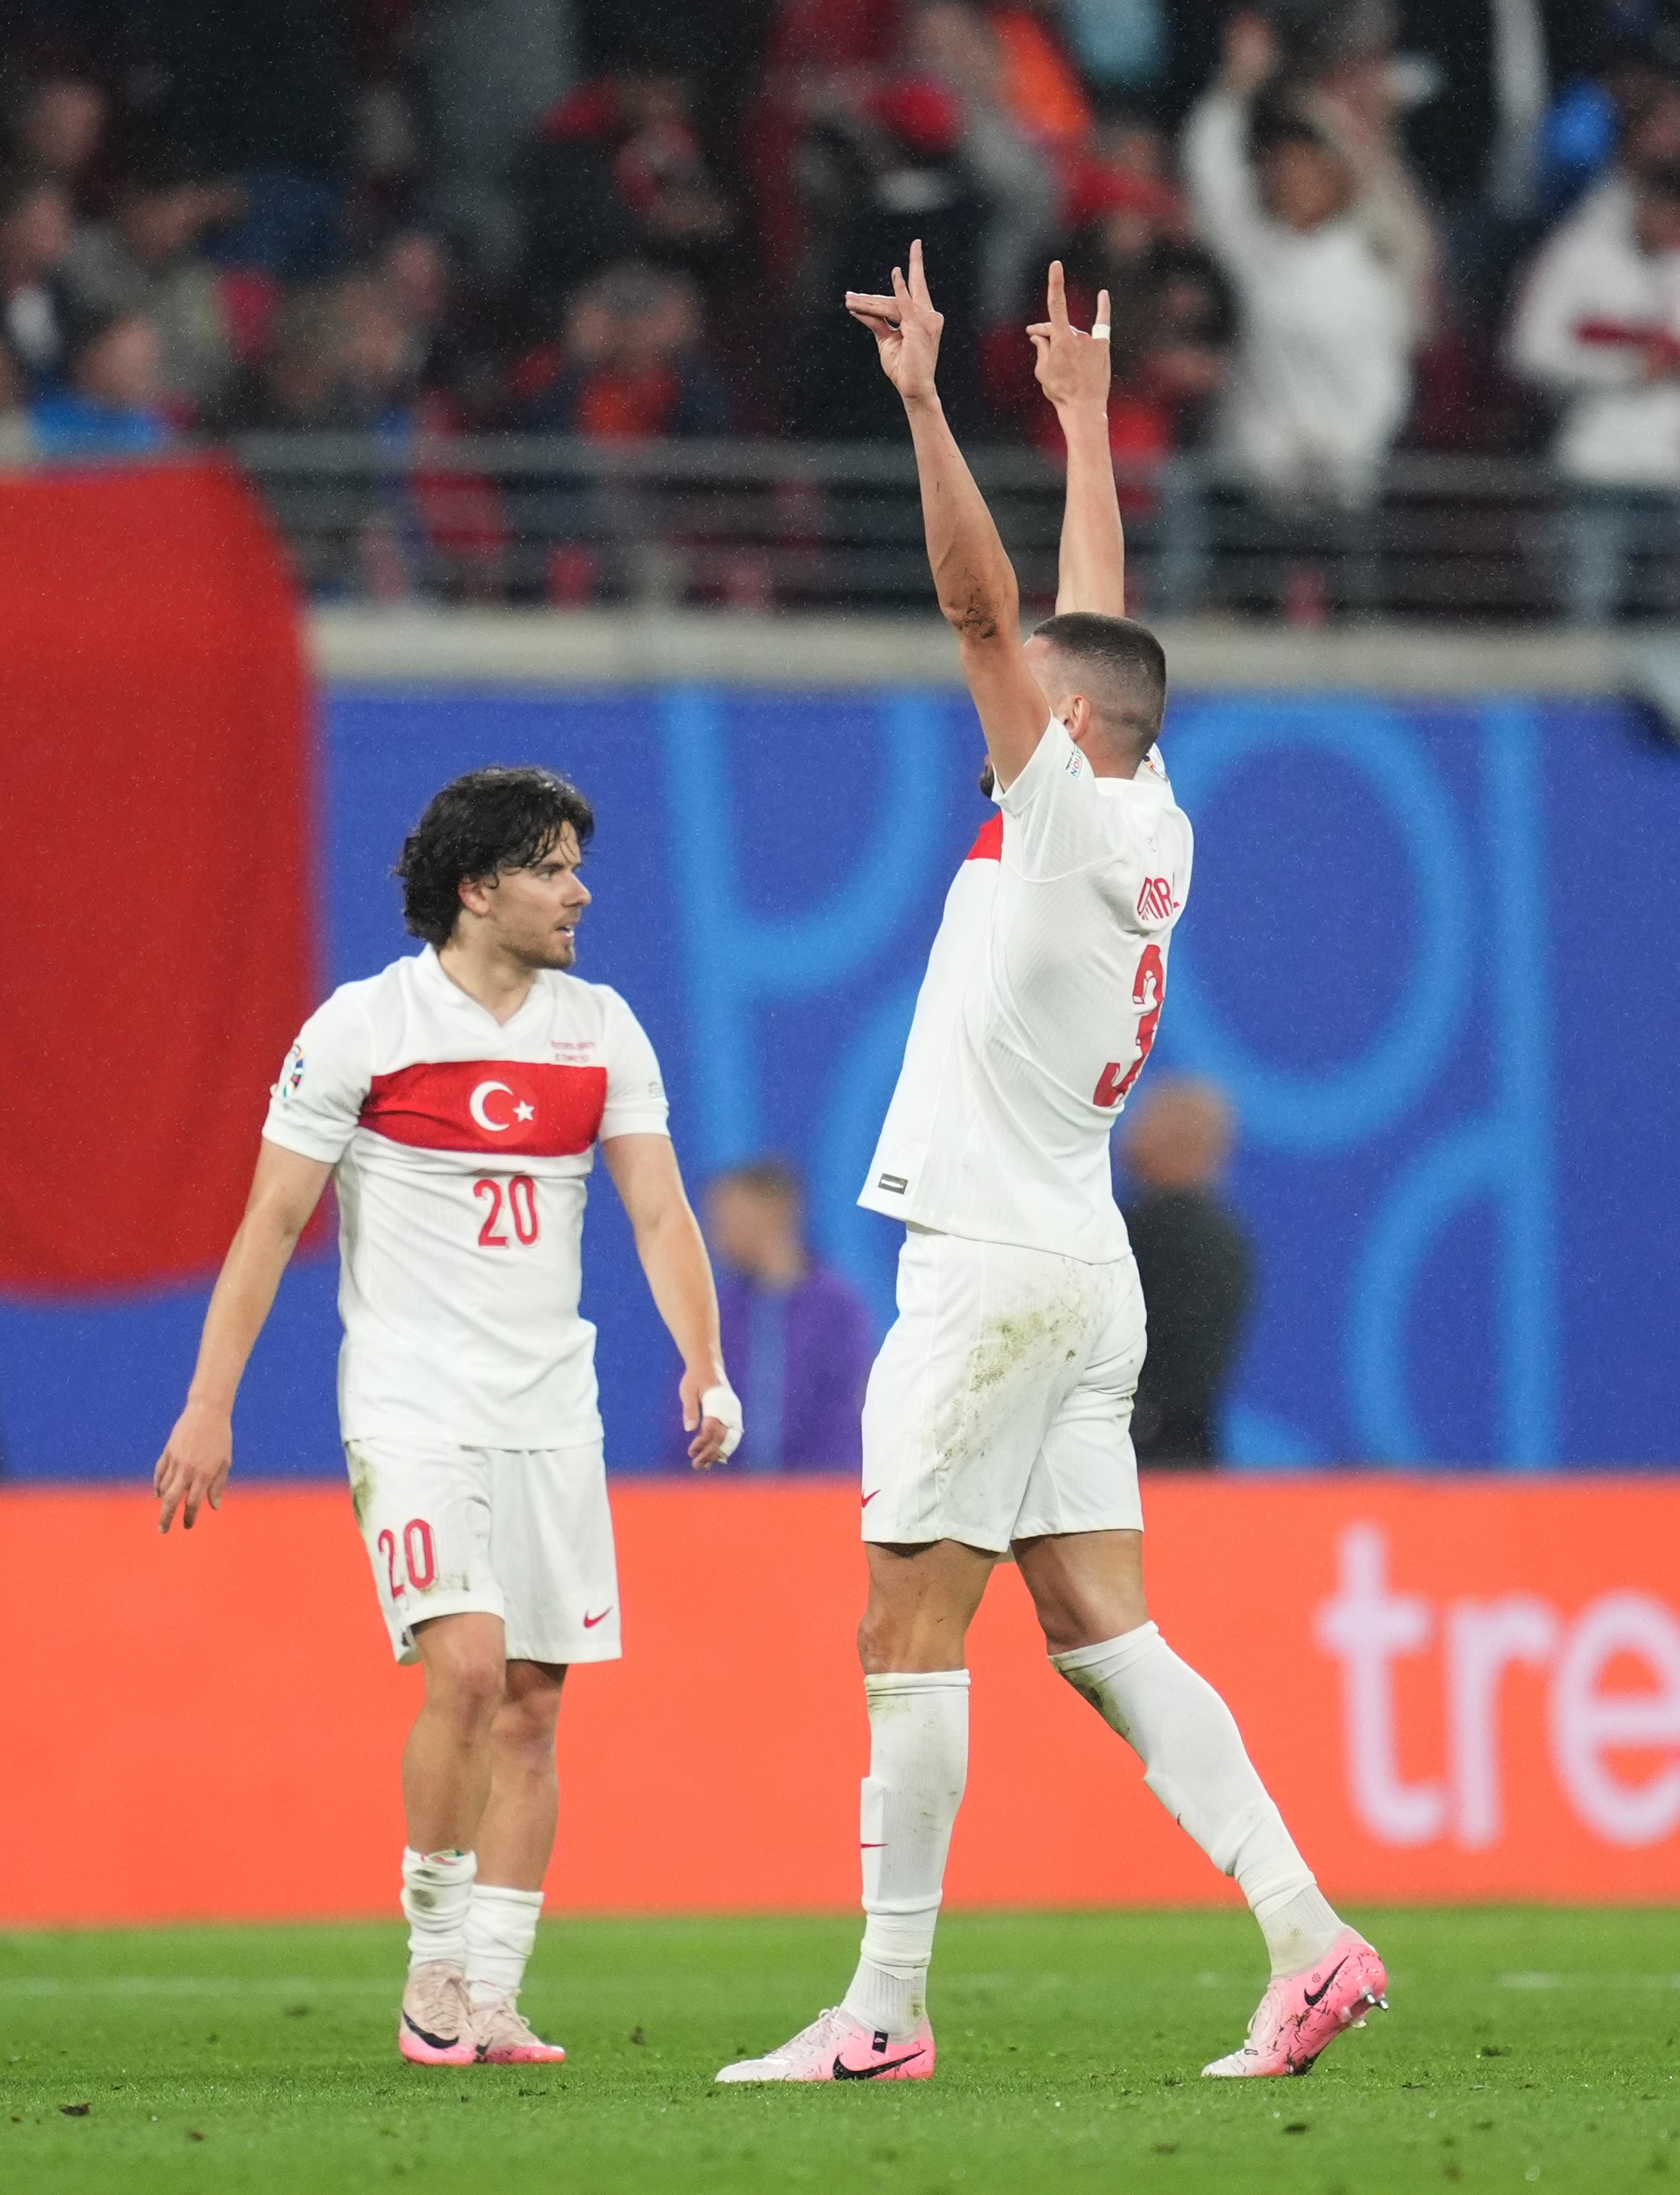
[{"left": 670, "top": 1159, "right": 874, "bottom": 1471}]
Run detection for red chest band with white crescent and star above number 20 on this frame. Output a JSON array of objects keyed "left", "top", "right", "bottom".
[{"left": 360, "top": 1060, "right": 606, "bottom": 1159}]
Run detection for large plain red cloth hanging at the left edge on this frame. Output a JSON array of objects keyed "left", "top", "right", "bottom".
[{"left": 0, "top": 463, "right": 316, "bottom": 1291}]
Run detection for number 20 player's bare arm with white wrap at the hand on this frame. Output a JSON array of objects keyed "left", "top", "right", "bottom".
[{"left": 602, "top": 1135, "right": 740, "bottom": 1471}]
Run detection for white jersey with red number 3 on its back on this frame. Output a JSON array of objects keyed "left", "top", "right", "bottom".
[{"left": 858, "top": 718, "right": 1191, "bottom": 1260}]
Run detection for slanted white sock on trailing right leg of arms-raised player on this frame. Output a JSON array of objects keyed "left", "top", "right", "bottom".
[{"left": 1050, "top": 1624, "right": 1342, "bottom": 1975}]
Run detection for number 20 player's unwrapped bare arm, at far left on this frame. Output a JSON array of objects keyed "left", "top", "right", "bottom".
[{"left": 152, "top": 1144, "right": 331, "bottom": 1532}]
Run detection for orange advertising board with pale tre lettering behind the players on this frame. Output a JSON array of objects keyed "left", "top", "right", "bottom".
[{"left": 0, "top": 1477, "right": 1680, "bottom": 1925}]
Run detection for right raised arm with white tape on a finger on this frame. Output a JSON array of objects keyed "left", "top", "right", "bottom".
[{"left": 1027, "top": 259, "right": 1127, "bottom": 617}]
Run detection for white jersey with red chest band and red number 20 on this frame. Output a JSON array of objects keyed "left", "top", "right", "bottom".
[{"left": 263, "top": 946, "right": 668, "bottom": 1449}]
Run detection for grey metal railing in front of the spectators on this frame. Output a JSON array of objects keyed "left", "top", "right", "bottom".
[{"left": 233, "top": 434, "right": 1673, "bottom": 628}]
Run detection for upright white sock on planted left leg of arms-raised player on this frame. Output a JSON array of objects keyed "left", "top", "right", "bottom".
[{"left": 843, "top": 1669, "right": 969, "bottom": 2035}]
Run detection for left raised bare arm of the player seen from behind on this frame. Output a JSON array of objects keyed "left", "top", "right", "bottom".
[{"left": 845, "top": 244, "right": 1050, "bottom": 786}]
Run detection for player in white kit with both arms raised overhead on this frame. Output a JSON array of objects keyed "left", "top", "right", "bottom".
[{"left": 718, "top": 246, "right": 1386, "bottom": 2081}]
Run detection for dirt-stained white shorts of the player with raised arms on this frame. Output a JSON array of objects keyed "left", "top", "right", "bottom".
[{"left": 863, "top": 1227, "right": 1144, "bottom": 1554}]
